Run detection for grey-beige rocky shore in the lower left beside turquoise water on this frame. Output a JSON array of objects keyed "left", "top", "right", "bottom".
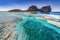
[{"left": 0, "top": 17, "right": 21, "bottom": 40}]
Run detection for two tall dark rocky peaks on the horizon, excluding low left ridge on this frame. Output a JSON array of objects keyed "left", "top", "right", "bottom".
[{"left": 27, "top": 6, "right": 51, "bottom": 12}]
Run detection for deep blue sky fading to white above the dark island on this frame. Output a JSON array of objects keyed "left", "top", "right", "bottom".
[{"left": 0, "top": 0, "right": 60, "bottom": 11}]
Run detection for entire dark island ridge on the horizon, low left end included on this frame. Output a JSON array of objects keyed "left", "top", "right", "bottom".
[{"left": 8, "top": 5, "right": 51, "bottom": 12}]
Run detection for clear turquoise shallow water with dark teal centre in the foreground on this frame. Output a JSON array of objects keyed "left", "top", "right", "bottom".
[{"left": 14, "top": 17, "right": 60, "bottom": 40}]
